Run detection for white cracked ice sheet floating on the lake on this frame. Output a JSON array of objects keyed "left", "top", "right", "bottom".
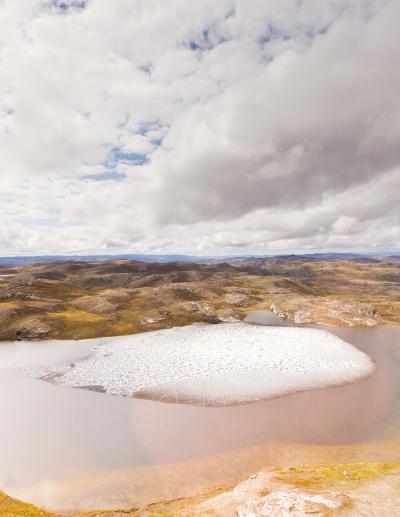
[{"left": 24, "top": 323, "right": 375, "bottom": 406}]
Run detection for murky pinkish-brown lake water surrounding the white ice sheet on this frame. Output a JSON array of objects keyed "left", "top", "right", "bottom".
[{"left": 0, "top": 312, "right": 400, "bottom": 510}]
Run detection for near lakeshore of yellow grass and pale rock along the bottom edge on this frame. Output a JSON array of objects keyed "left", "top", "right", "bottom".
[{"left": 0, "top": 463, "right": 400, "bottom": 517}]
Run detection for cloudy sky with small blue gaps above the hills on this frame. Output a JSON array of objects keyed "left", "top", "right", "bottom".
[{"left": 0, "top": 0, "right": 400, "bottom": 256}]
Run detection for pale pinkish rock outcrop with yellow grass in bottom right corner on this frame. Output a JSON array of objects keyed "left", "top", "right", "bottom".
[{"left": 191, "top": 463, "right": 400, "bottom": 517}]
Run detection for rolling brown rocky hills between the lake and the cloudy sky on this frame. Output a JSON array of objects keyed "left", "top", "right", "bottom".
[{"left": 0, "top": 257, "right": 400, "bottom": 340}]
